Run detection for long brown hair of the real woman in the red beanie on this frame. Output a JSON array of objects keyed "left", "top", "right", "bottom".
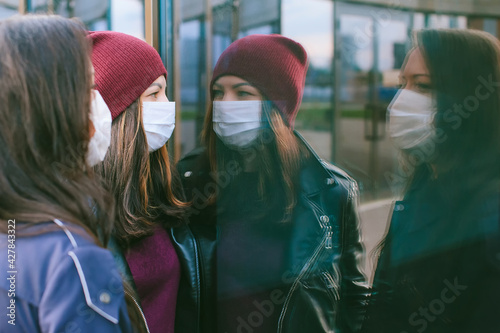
[{"left": 96, "top": 99, "right": 187, "bottom": 247}]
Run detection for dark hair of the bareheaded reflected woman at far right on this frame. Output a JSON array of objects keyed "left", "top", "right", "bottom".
[{"left": 415, "top": 29, "right": 500, "bottom": 191}]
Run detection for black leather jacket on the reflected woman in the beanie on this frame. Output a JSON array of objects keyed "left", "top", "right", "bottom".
[{"left": 173, "top": 133, "right": 368, "bottom": 333}]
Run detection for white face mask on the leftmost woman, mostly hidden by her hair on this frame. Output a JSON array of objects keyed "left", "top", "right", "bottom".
[{"left": 86, "top": 90, "right": 111, "bottom": 166}]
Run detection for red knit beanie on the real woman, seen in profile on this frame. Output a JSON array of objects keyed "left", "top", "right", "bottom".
[{"left": 89, "top": 31, "right": 167, "bottom": 120}]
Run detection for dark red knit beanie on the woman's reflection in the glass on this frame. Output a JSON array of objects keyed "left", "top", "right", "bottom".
[{"left": 210, "top": 34, "right": 308, "bottom": 128}]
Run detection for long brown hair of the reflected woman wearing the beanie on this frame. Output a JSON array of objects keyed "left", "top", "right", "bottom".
[{"left": 201, "top": 97, "right": 307, "bottom": 221}]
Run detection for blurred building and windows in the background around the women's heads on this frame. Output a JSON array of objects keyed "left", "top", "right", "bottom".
[{"left": 5, "top": 0, "right": 500, "bottom": 202}]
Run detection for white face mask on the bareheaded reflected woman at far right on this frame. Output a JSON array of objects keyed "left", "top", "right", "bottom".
[{"left": 388, "top": 89, "right": 437, "bottom": 149}]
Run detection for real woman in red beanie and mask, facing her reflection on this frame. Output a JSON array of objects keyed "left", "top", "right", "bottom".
[{"left": 89, "top": 31, "right": 194, "bottom": 333}]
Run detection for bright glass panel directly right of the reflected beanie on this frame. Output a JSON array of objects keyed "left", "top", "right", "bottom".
[{"left": 281, "top": 0, "right": 333, "bottom": 160}]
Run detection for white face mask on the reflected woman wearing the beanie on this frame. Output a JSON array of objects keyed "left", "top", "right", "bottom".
[{"left": 212, "top": 101, "right": 262, "bottom": 148}]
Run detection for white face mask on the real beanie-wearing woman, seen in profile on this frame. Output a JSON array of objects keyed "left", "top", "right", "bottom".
[{"left": 142, "top": 102, "right": 175, "bottom": 152}]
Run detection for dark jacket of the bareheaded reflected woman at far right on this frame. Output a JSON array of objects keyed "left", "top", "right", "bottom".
[{"left": 363, "top": 171, "right": 500, "bottom": 333}]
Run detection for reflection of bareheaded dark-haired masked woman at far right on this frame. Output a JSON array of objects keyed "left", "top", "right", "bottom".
[{"left": 364, "top": 30, "right": 500, "bottom": 333}]
